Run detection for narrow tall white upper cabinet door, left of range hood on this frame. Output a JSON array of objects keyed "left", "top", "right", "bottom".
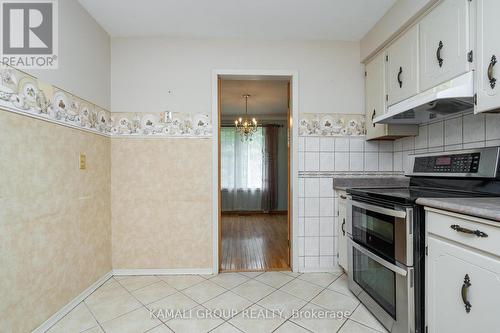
[{"left": 365, "top": 53, "right": 387, "bottom": 140}]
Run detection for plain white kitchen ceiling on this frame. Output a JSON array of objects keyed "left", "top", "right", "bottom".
[{"left": 79, "top": 0, "right": 396, "bottom": 41}]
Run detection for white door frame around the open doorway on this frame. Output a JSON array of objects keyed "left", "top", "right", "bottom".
[{"left": 211, "top": 69, "right": 299, "bottom": 274}]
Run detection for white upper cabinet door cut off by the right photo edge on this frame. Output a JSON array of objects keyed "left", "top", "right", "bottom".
[{"left": 475, "top": 0, "right": 500, "bottom": 112}]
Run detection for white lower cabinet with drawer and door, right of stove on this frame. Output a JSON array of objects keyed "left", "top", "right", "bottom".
[{"left": 426, "top": 211, "right": 500, "bottom": 333}]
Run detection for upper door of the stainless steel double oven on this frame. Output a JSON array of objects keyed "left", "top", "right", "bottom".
[{"left": 347, "top": 199, "right": 413, "bottom": 266}]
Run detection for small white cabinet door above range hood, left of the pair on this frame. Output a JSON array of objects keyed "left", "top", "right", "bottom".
[{"left": 387, "top": 24, "right": 418, "bottom": 105}]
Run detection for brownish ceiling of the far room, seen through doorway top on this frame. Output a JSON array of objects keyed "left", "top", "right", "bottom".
[{"left": 221, "top": 80, "right": 288, "bottom": 118}]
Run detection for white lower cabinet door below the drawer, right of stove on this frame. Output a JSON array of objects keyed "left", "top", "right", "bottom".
[{"left": 426, "top": 235, "right": 500, "bottom": 333}]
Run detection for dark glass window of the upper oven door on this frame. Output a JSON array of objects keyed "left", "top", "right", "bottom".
[{"left": 352, "top": 206, "right": 396, "bottom": 263}]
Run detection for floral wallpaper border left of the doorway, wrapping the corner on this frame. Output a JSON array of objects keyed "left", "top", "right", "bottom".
[{"left": 0, "top": 64, "right": 212, "bottom": 138}]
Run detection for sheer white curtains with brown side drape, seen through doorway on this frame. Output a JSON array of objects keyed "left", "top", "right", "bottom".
[{"left": 221, "top": 126, "right": 278, "bottom": 211}]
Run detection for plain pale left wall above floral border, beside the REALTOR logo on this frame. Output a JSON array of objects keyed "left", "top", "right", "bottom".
[{"left": 27, "top": 0, "right": 111, "bottom": 109}]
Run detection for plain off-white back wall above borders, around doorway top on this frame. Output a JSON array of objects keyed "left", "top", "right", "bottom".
[{"left": 111, "top": 37, "right": 364, "bottom": 113}]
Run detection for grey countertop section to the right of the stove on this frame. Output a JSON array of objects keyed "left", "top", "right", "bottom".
[{"left": 416, "top": 198, "right": 500, "bottom": 222}]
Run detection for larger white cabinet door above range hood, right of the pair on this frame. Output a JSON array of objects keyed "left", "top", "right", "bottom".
[{"left": 419, "top": 0, "right": 470, "bottom": 91}]
